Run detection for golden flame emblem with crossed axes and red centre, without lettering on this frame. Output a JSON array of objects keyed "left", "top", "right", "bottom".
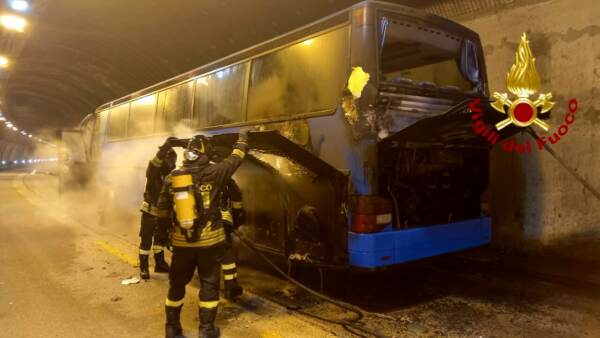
[{"left": 491, "top": 33, "right": 554, "bottom": 131}]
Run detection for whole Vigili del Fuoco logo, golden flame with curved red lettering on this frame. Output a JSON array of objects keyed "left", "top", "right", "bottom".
[{"left": 469, "top": 33, "right": 577, "bottom": 153}]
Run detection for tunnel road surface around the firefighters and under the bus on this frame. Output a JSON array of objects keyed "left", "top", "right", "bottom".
[{"left": 0, "top": 172, "right": 600, "bottom": 338}]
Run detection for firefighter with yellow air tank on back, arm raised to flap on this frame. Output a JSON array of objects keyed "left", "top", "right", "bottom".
[{"left": 158, "top": 131, "right": 248, "bottom": 337}]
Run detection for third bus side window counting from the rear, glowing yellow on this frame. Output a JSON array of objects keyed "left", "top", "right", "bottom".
[{"left": 154, "top": 81, "right": 194, "bottom": 133}]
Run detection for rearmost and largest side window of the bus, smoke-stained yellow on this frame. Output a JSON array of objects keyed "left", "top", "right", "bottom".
[{"left": 248, "top": 26, "right": 349, "bottom": 121}]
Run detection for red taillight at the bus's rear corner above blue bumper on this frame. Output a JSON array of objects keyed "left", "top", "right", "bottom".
[{"left": 351, "top": 196, "right": 392, "bottom": 233}]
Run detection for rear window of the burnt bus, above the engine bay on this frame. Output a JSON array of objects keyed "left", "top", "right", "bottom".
[{"left": 379, "top": 15, "right": 480, "bottom": 92}]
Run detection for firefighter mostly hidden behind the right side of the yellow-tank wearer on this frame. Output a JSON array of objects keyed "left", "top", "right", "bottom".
[{"left": 221, "top": 179, "right": 245, "bottom": 300}]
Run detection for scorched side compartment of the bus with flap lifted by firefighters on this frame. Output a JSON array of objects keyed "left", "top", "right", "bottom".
[{"left": 213, "top": 131, "right": 347, "bottom": 265}]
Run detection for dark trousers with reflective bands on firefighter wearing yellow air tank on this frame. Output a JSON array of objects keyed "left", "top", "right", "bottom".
[{"left": 165, "top": 246, "right": 223, "bottom": 331}]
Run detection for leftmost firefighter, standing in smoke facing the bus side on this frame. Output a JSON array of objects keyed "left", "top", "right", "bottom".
[{"left": 139, "top": 137, "right": 177, "bottom": 279}]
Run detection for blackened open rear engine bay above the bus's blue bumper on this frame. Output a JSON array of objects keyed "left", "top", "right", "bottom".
[{"left": 378, "top": 100, "right": 518, "bottom": 228}]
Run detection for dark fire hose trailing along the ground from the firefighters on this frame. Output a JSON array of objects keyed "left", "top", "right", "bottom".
[{"left": 233, "top": 231, "right": 387, "bottom": 338}]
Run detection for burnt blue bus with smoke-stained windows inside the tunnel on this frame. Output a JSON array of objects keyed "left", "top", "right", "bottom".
[{"left": 70, "top": 0, "right": 500, "bottom": 269}]
